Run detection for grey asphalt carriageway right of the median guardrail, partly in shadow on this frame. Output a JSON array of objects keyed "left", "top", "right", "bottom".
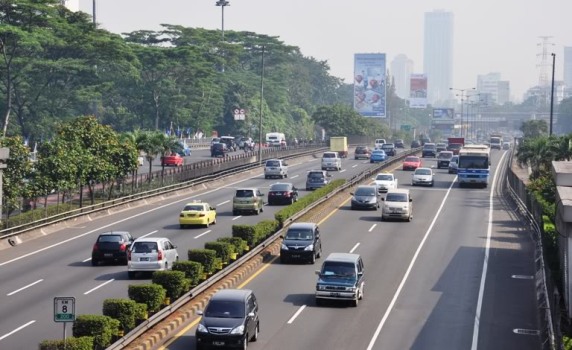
[{"left": 162, "top": 151, "right": 541, "bottom": 350}]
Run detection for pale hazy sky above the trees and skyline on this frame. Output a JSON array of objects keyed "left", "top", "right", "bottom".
[{"left": 80, "top": 0, "right": 572, "bottom": 100}]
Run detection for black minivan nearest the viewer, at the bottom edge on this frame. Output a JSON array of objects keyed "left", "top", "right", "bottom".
[{"left": 195, "top": 289, "right": 260, "bottom": 350}]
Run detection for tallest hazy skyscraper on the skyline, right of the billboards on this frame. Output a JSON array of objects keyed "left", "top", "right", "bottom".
[{"left": 423, "top": 10, "right": 454, "bottom": 105}]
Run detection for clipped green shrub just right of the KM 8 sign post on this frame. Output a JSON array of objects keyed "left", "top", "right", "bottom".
[{"left": 73, "top": 315, "right": 121, "bottom": 350}]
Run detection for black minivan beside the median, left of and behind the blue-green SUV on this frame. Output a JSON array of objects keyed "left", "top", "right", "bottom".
[{"left": 280, "top": 222, "right": 322, "bottom": 264}]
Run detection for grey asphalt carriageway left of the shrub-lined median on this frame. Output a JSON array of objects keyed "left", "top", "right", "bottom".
[{"left": 0, "top": 151, "right": 380, "bottom": 350}]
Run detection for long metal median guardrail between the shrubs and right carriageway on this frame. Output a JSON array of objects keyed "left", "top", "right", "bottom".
[{"left": 107, "top": 148, "right": 421, "bottom": 350}]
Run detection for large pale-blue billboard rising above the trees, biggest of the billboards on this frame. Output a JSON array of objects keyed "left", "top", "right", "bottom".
[{"left": 354, "top": 53, "right": 387, "bottom": 118}]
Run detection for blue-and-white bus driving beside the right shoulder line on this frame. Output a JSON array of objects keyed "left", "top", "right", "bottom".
[{"left": 457, "top": 145, "right": 491, "bottom": 188}]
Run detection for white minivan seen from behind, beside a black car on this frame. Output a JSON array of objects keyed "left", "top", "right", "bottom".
[{"left": 127, "top": 237, "right": 179, "bottom": 278}]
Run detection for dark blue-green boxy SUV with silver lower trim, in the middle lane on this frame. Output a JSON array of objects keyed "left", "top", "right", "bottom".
[{"left": 315, "top": 253, "right": 365, "bottom": 307}]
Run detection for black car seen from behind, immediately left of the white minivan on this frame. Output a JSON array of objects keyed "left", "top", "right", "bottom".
[{"left": 91, "top": 231, "right": 135, "bottom": 266}]
